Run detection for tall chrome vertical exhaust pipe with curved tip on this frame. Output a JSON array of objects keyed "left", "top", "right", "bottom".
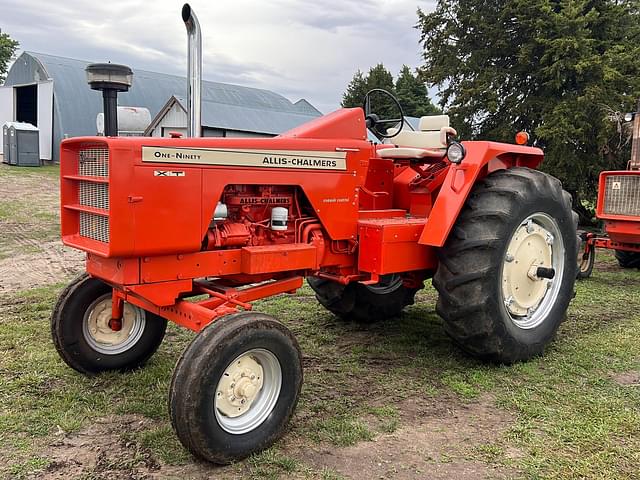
[{"left": 182, "top": 3, "right": 202, "bottom": 137}]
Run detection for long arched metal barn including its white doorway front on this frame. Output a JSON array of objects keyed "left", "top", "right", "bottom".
[{"left": 0, "top": 52, "right": 319, "bottom": 160}]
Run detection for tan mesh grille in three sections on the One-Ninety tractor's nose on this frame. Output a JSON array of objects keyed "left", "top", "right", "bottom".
[{"left": 78, "top": 148, "right": 109, "bottom": 243}]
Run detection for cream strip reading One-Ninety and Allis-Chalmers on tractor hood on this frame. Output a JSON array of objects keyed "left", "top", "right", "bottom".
[{"left": 142, "top": 147, "right": 347, "bottom": 170}]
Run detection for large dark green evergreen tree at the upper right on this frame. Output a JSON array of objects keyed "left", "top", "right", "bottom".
[{"left": 418, "top": 0, "right": 640, "bottom": 202}]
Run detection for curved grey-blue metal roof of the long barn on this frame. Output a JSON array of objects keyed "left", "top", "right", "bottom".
[{"left": 5, "top": 52, "right": 320, "bottom": 158}]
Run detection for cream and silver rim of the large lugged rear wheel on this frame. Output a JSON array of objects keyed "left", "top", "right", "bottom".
[{"left": 500, "top": 212, "right": 565, "bottom": 330}]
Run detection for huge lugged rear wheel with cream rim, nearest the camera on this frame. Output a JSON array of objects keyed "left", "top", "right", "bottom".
[{"left": 433, "top": 168, "right": 577, "bottom": 363}]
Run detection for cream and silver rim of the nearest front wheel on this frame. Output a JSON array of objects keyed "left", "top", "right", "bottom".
[{"left": 213, "top": 348, "right": 282, "bottom": 435}]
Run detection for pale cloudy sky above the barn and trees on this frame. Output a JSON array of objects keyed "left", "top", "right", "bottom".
[{"left": 0, "top": 0, "right": 435, "bottom": 112}]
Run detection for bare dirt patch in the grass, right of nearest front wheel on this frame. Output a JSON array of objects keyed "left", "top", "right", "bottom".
[{"left": 302, "top": 396, "right": 514, "bottom": 480}]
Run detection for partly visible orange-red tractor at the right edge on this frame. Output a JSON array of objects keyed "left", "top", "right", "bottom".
[{"left": 578, "top": 102, "right": 640, "bottom": 278}]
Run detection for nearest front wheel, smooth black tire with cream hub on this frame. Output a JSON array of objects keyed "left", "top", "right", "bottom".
[{"left": 169, "top": 312, "right": 302, "bottom": 464}]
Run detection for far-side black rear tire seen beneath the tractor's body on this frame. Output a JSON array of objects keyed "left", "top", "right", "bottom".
[{"left": 307, "top": 275, "right": 418, "bottom": 323}]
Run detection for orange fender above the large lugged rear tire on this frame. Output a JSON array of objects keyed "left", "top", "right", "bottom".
[{"left": 418, "top": 142, "right": 544, "bottom": 247}]
